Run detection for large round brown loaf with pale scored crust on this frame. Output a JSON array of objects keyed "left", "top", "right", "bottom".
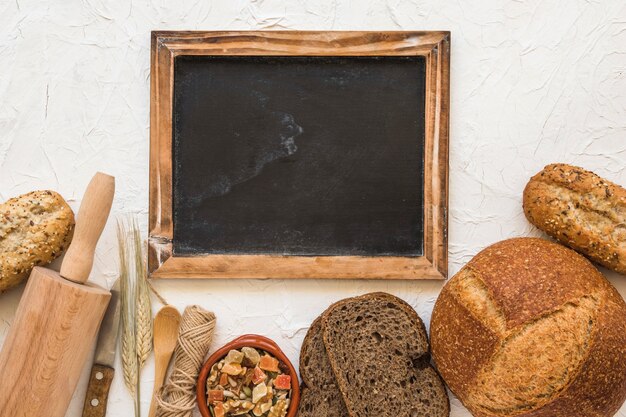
[{"left": 431, "top": 238, "right": 626, "bottom": 417}]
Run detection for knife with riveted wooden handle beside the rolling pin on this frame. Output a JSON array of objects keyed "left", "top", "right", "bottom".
[{"left": 83, "top": 279, "right": 120, "bottom": 417}]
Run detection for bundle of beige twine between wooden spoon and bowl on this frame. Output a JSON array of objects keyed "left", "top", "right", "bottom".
[{"left": 156, "top": 306, "right": 215, "bottom": 417}]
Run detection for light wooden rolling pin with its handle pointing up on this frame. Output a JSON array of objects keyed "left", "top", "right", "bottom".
[{"left": 0, "top": 173, "right": 115, "bottom": 417}]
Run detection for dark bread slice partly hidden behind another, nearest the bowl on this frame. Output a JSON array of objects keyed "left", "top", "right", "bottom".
[{"left": 297, "top": 317, "right": 348, "bottom": 417}]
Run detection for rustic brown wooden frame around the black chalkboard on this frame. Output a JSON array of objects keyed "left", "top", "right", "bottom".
[{"left": 148, "top": 31, "right": 450, "bottom": 279}]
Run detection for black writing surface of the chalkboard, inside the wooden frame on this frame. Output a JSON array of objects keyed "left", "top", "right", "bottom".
[{"left": 173, "top": 56, "right": 426, "bottom": 256}]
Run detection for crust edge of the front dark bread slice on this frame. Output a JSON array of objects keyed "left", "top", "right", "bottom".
[{"left": 322, "top": 292, "right": 450, "bottom": 417}]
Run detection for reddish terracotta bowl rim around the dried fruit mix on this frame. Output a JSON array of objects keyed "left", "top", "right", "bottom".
[{"left": 196, "top": 334, "right": 300, "bottom": 417}]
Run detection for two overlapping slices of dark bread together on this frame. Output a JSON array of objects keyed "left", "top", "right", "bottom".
[{"left": 297, "top": 293, "right": 450, "bottom": 417}]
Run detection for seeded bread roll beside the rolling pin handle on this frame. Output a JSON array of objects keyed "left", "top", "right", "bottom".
[{"left": 0, "top": 191, "right": 74, "bottom": 293}]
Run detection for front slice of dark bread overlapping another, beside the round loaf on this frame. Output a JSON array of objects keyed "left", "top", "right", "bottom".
[{"left": 322, "top": 293, "right": 450, "bottom": 417}]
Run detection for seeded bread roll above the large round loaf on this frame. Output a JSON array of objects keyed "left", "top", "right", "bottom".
[{"left": 524, "top": 164, "right": 626, "bottom": 274}]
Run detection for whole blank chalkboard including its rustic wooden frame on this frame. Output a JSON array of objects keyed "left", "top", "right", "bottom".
[{"left": 148, "top": 31, "right": 450, "bottom": 279}]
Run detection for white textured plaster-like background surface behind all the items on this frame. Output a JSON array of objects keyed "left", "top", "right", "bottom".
[{"left": 0, "top": 0, "right": 626, "bottom": 417}]
